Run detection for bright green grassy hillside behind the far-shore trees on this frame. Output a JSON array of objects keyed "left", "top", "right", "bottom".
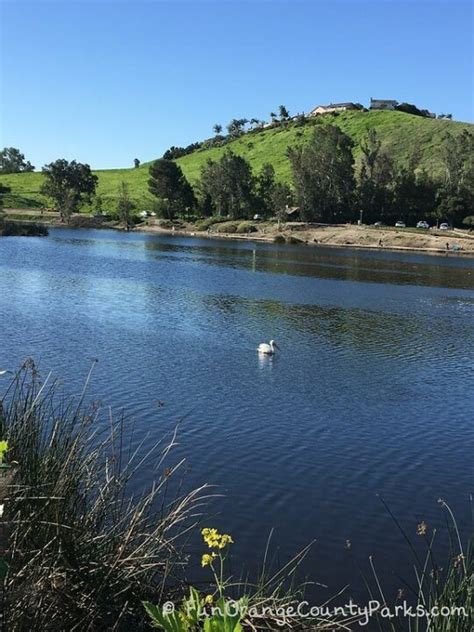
[{"left": 0, "top": 111, "right": 474, "bottom": 210}]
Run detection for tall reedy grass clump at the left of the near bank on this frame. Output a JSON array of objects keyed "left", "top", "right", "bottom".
[{"left": 0, "top": 361, "right": 206, "bottom": 632}]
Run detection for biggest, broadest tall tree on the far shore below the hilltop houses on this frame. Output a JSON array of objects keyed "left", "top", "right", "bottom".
[{"left": 288, "top": 125, "right": 355, "bottom": 222}]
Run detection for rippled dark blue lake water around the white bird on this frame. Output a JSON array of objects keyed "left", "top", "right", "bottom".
[{"left": 0, "top": 229, "right": 474, "bottom": 596}]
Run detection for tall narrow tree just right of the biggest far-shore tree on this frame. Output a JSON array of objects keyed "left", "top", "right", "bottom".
[{"left": 357, "top": 129, "right": 394, "bottom": 223}]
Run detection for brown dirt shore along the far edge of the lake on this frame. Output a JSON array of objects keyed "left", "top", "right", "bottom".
[{"left": 5, "top": 209, "right": 474, "bottom": 257}]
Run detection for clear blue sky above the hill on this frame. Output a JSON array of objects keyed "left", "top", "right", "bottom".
[{"left": 0, "top": 0, "right": 473, "bottom": 169}]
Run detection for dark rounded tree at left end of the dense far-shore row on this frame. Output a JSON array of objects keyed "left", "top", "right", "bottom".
[{"left": 148, "top": 158, "right": 195, "bottom": 219}]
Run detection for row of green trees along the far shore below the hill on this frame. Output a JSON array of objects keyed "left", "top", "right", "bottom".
[{"left": 5, "top": 124, "right": 474, "bottom": 227}]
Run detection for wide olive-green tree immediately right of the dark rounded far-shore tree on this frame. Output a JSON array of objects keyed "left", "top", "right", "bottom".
[{"left": 199, "top": 151, "right": 255, "bottom": 219}]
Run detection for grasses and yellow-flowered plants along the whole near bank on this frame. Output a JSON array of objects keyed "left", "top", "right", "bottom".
[{"left": 0, "top": 361, "right": 474, "bottom": 632}]
